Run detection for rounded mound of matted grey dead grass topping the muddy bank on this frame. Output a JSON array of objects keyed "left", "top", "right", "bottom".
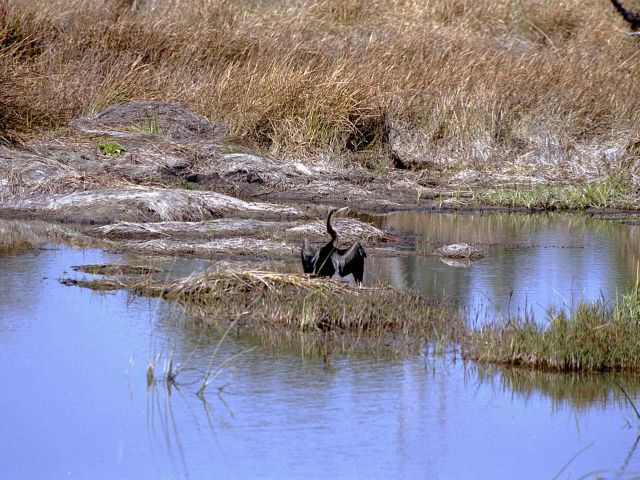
[{"left": 70, "top": 100, "right": 225, "bottom": 142}]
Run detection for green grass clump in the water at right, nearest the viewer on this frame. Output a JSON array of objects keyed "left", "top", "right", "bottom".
[{"left": 466, "top": 274, "right": 640, "bottom": 371}]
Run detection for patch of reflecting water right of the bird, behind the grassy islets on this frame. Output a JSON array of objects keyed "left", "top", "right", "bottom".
[{"left": 368, "top": 212, "right": 640, "bottom": 322}]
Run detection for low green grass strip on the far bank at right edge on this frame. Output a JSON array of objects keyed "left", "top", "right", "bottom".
[{"left": 479, "top": 174, "right": 640, "bottom": 210}]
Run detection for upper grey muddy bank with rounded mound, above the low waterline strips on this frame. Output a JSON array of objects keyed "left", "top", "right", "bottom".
[{"left": 0, "top": 102, "right": 440, "bottom": 224}]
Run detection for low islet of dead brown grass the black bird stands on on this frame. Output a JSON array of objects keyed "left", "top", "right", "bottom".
[{"left": 65, "top": 270, "right": 464, "bottom": 349}]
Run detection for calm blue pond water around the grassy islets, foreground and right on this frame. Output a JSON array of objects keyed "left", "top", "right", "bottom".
[{"left": 0, "top": 214, "right": 640, "bottom": 479}]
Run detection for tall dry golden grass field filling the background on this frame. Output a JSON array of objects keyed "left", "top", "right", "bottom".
[{"left": 0, "top": 0, "right": 640, "bottom": 171}]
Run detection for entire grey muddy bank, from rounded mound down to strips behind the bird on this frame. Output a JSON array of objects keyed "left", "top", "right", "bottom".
[{"left": 0, "top": 101, "right": 636, "bottom": 266}]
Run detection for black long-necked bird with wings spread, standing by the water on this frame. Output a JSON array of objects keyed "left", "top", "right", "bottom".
[{"left": 300, "top": 207, "right": 367, "bottom": 285}]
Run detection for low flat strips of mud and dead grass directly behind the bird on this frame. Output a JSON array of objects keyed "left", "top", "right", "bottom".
[{"left": 0, "top": 213, "right": 402, "bottom": 262}]
